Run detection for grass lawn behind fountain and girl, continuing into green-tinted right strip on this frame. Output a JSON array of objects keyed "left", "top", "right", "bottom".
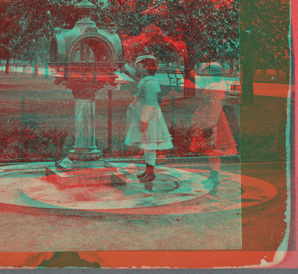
[{"left": 0, "top": 71, "right": 286, "bottom": 162}]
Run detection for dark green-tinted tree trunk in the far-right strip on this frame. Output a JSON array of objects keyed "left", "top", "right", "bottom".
[{"left": 240, "top": 32, "right": 254, "bottom": 104}]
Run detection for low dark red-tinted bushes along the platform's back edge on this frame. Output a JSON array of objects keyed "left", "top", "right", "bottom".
[{"left": 0, "top": 120, "right": 246, "bottom": 162}]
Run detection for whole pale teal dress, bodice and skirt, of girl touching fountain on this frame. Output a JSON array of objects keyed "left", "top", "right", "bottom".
[{"left": 124, "top": 76, "right": 173, "bottom": 150}]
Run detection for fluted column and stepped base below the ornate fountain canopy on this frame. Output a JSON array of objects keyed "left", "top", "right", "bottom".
[{"left": 46, "top": 84, "right": 123, "bottom": 188}]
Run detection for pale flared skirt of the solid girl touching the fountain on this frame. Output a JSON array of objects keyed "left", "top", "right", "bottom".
[{"left": 124, "top": 100, "right": 173, "bottom": 150}]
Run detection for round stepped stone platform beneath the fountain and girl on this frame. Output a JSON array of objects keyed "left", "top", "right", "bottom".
[{"left": 0, "top": 163, "right": 277, "bottom": 215}]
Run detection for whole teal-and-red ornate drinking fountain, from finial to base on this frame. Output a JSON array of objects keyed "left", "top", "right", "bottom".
[{"left": 46, "top": 0, "right": 124, "bottom": 186}]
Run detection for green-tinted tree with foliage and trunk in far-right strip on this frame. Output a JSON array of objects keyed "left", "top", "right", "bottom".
[{"left": 240, "top": 0, "right": 289, "bottom": 103}]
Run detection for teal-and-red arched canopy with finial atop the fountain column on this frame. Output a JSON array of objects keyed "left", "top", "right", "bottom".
[{"left": 49, "top": 0, "right": 123, "bottom": 88}]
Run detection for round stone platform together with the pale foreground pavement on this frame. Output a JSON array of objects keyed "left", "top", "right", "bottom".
[{"left": 0, "top": 159, "right": 277, "bottom": 252}]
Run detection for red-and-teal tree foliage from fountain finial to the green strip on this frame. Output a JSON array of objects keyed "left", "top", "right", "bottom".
[{"left": 96, "top": 0, "right": 239, "bottom": 95}]
